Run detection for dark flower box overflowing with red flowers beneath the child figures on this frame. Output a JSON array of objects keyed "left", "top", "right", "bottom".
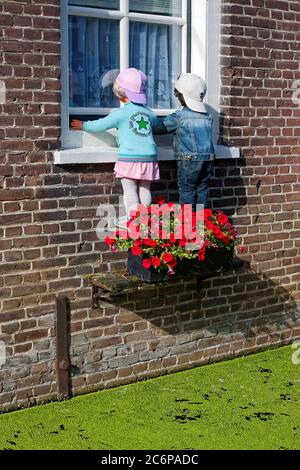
[{"left": 105, "top": 197, "right": 237, "bottom": 282}]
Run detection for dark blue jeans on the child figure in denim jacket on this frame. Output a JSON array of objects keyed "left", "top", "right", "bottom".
[{"left": 177, "top": 160, "right": 213, "bottom": 210}]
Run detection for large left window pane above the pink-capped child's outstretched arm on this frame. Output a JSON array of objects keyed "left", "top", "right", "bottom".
[{"left": 69, "top": 16, "right": 120, "bottom": 108}]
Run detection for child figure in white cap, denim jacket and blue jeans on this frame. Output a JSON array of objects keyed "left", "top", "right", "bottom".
[{"left": 153, "top": 73, "right": 215, "bottom": 210}]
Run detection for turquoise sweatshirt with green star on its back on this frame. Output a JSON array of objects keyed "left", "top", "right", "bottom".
[{"left": 82, "top": 102, "right": 157, "bottom": 162}]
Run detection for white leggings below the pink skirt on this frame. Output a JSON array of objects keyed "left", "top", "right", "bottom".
[{"left": 121, "top": 178, "right": 151, "bottom": 216}]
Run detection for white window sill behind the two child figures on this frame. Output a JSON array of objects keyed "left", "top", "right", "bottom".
[{"left": 54, "top": 145, "right": 240, "bottom": 165}]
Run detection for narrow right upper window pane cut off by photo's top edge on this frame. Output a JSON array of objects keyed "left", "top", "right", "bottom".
[{"left": 129, "top": 0, "right": 182, "bottom": 16}]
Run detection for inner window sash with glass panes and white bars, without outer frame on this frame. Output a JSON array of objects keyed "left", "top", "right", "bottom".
[{"left": 68, "top": 0, "right": 190, "bottom": 115}]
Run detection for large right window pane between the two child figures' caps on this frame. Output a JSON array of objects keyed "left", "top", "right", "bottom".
[{"left": 129, "top": 22, "right": 181, "bottom": 109}]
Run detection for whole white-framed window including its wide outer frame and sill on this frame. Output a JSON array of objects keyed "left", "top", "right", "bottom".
[{"left": 55, "top": 0, "right": 240, "bottom": 163}]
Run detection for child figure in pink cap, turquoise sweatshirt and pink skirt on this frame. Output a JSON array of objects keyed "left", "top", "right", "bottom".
[{"left": 71, "top": 68, "right": 160, "bottom": 228}]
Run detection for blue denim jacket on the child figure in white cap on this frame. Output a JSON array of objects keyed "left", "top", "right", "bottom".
[{"left": 152, "top": 107, "right": 214, "bottom": 161}]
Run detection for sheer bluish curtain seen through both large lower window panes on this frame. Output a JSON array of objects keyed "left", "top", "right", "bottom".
[{"left": 69, "top": 16, "right": 181, "bottom": 109}]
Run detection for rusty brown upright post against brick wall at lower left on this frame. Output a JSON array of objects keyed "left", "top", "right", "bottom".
[{"left": 56, "top": 296, "right": 70, "bottom": 400}]
